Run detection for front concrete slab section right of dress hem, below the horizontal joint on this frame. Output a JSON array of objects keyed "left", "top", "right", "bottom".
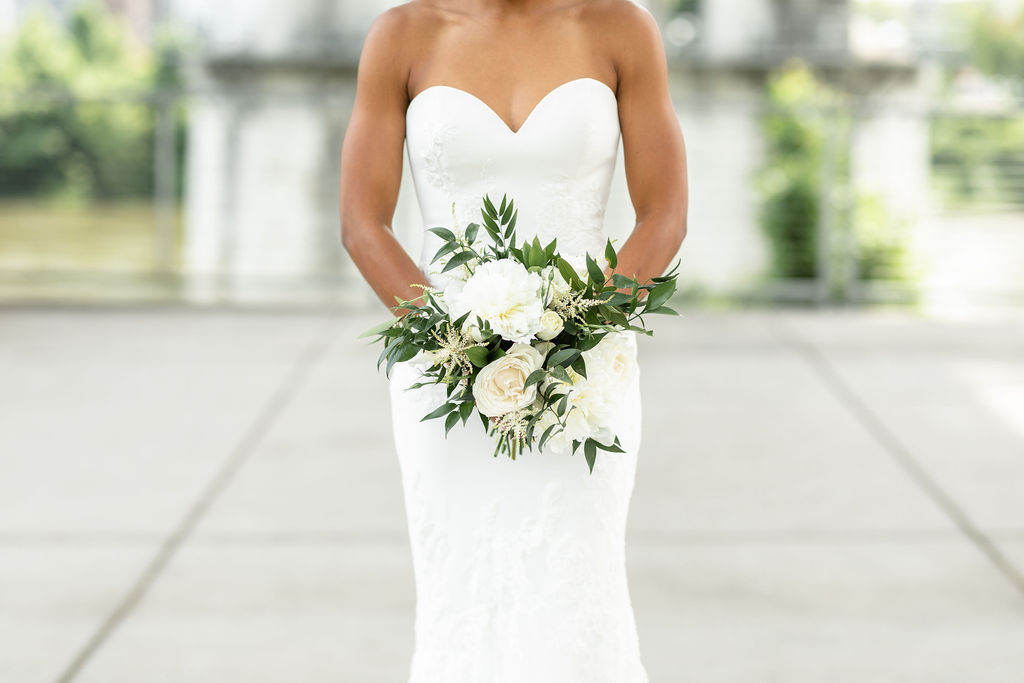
[{"left": 629, "top": 537, "right": 1024, "bottom": 683}]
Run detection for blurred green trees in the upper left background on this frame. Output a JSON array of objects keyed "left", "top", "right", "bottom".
[{"left": 0, "top": 2, "right": 185, "bottom": 200}]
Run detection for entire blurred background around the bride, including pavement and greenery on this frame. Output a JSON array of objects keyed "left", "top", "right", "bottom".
[{"left": 0, "top": 0, "right": 1024, "bottom": 683}]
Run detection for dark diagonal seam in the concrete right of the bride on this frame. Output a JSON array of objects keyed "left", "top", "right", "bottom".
[{"left": 767, "top": 318, "right": 1024, "bottom": 594}]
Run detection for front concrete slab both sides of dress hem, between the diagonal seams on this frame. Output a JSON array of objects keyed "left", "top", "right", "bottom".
[{"left": 66, "top": 536, "right": 1024, "bottom": 683}]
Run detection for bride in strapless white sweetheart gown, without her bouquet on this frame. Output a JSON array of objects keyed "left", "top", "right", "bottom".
[{"left": 340, "top": 0, "right": 687, "bottom": 683}]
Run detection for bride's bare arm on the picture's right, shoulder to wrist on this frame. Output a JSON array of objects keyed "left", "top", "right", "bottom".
[{"left": 608, "top": 2, "right": 687, "bottom": 284}]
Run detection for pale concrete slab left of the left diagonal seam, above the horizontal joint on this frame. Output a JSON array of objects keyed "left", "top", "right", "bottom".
[{"left": 0, "top": 311, "right": 323, "bottom": 533}]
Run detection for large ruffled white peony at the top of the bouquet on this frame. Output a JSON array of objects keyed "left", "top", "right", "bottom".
[{"left": 449, "top": 259, "right": 544, "bottom": 342}]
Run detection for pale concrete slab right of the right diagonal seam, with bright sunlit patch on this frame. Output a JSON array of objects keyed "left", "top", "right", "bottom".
[{"left": 778, "top": 314, "right": 1024, "bottom": 529}]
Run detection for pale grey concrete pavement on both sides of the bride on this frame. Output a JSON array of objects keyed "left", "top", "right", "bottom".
[{"left": 0, "top": 307, "right": 1024, "bottom": 683}]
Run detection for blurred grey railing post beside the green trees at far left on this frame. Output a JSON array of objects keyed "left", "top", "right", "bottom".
[{"left": 153, "top": 93, "right": 177, "bottom": 274}]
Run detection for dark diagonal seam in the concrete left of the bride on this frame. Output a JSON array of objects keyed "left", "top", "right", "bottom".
[{"left": 56, "top": 313, "right": 337, "bottom": 683}]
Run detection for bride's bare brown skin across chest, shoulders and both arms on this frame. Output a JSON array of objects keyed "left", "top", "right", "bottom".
[{"left": 340, "top": 0, "right": 687, "bottom": 315}]
